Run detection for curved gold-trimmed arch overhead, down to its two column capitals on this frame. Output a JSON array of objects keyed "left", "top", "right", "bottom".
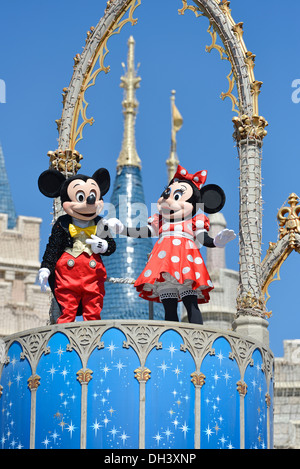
[{"left": 49, "top": 0, "right": 268, "bottom": 174}]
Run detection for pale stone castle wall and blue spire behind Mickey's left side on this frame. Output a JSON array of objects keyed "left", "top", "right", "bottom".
[{"left": 0, "top": 145, "right": 49, "bottom": 336}]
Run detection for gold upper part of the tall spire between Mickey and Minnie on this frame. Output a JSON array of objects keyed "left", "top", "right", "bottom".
[{"left": 117, "top": 36, "right": 141, "bottom": 169}]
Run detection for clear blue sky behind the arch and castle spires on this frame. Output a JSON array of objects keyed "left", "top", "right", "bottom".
[{"left": 0, "top": 0, "right": 300, "bottom": 356}]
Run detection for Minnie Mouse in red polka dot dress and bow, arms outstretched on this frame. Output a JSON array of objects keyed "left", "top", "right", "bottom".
[{"left": 107, "top": 165, "right": 236, "bottom": 324}]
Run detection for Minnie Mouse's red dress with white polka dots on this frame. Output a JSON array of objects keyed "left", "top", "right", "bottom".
[{"left": 135, "top": 214, "right": 213, "bottom": 303}]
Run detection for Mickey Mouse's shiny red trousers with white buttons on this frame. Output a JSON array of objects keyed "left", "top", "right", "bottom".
[{"left": 54, "top": 252, "right": 106, "bottom": 323}]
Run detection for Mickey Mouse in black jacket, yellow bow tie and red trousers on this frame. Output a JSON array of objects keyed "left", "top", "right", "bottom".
[{"left": 38, "top": 168, "right": 116, "bottom": 323}]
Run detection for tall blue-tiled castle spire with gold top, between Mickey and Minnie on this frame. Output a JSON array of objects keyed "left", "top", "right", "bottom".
[{"left": 101, "top": 36, "right": 163, "bottom": 319}]
